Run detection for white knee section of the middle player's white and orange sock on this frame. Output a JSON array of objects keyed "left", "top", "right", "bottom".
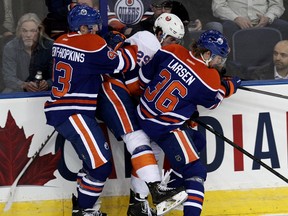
[{"left": 122, "top": 130, "right": 151, "bottom": 155}]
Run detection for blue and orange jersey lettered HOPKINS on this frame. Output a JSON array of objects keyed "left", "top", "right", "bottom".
[{"left": 44, "top": 33, "right": 137, "bottom": 126}]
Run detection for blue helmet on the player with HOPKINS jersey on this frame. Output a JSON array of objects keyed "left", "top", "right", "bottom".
[{"left": 67, "top": 5, "right": 102, "bottom": 31}]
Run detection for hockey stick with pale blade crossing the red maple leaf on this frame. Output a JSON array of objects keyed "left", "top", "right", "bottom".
[{"left": 4, "top": 130, "right": 56, "bottom": 211}]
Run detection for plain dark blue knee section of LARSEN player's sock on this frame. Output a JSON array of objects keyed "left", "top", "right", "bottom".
[{"left": 181, "top": 159, "right": 207, "bottom": 182}]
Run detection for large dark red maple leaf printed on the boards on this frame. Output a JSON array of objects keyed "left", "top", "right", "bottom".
[{"left": 0, "top": 111, "right": 61, "bottom": 186}]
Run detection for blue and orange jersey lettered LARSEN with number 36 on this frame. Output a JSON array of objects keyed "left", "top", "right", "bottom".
[{"left": 137, "top": 44, "right": 225, "bottom": 138}]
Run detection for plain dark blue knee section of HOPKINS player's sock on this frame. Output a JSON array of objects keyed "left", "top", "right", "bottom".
[{"left": 84, "top": 160, "right": 112, "bottom": 182}]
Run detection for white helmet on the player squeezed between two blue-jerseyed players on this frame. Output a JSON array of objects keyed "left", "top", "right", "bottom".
[{"left": 153, "top": 13, "right": 185, "bottom": 40}]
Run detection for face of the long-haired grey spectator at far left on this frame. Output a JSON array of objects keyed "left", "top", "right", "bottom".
[{"left": 20, "top": 21, "right": 39, "bottom": 47}]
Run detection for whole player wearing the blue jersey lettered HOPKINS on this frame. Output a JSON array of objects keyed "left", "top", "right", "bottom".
[{"left": 44, "top": 5, "right": 137, "bottom": 216}]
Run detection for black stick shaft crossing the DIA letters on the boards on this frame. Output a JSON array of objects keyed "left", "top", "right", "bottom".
[{"left": 193, "top": 119, "right": 288, "bottom": 183}]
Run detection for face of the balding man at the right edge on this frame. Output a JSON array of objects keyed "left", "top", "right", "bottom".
[{"left": 273, "top": 42, "right": 288, "bottom": 70}]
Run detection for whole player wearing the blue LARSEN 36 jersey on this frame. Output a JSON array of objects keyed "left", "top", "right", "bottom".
[{"left": 137, "top": 30, "right": 241, "bottom": 216}]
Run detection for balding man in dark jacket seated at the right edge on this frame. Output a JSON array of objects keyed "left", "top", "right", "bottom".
[{"left": 251, "top": 40, "right": 288, "bottom": 80}]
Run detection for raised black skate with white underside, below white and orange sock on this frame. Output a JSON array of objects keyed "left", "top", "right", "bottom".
[{"left": 147, "top": 182, "right": 188, "bottom": 215}]
